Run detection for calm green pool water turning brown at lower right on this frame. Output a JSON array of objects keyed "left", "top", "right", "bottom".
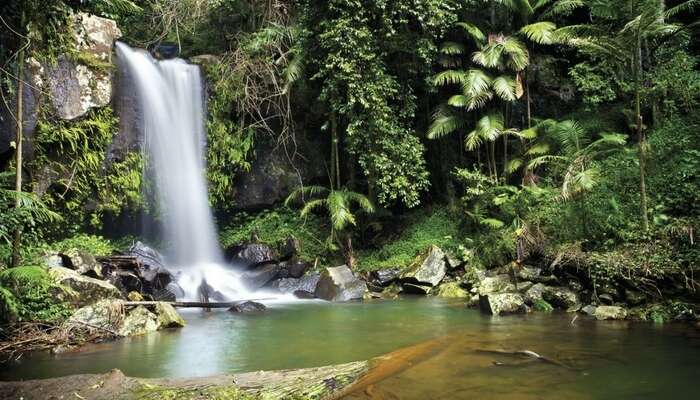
[{"left": 0, "top": 298, "right": 700, "bottom": 399}]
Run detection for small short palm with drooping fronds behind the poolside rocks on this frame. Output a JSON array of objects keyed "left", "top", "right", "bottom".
[{"left": 284, "top": 186, "right": 374, "bottom": 268}]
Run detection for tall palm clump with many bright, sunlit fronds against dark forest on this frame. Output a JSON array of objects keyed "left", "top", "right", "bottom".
[{"left": 428, "top": 0, "right": 557, "bottom": 180}]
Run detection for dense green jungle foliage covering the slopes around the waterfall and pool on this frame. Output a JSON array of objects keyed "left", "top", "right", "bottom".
[{"left": 0, "top": 0, "right": 700, "bottom": 317}]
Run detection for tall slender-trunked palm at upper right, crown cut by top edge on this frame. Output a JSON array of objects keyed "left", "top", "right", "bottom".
[{"left": 560, "top": 0, "right": 698, "bottom": 231}]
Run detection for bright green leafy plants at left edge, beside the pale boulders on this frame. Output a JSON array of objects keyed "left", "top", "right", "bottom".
[{"left": 0, "top": 267, "right": 70, "bottom": 323}]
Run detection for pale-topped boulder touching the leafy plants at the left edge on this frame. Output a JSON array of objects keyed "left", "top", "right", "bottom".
[{"left": 49, "top": 267, "right": 122, "bottom": 307}]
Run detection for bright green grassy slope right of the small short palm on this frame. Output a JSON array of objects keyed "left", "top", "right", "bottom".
[{"left": 357, "top": 207, "right": 463, "bottom": 270}]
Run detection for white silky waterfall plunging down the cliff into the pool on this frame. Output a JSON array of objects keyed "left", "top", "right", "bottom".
[{"left": 116, "top": 43, "right": 249, "bottom": 300}]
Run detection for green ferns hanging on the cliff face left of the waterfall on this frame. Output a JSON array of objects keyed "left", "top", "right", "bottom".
[{"left": 30, "top": 107, "right": 143, "bottom": 231}]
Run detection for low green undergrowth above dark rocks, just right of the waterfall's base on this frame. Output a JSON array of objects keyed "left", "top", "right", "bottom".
[{"left": 219, "top": 207, "right": 327, "bottom": 261}]
